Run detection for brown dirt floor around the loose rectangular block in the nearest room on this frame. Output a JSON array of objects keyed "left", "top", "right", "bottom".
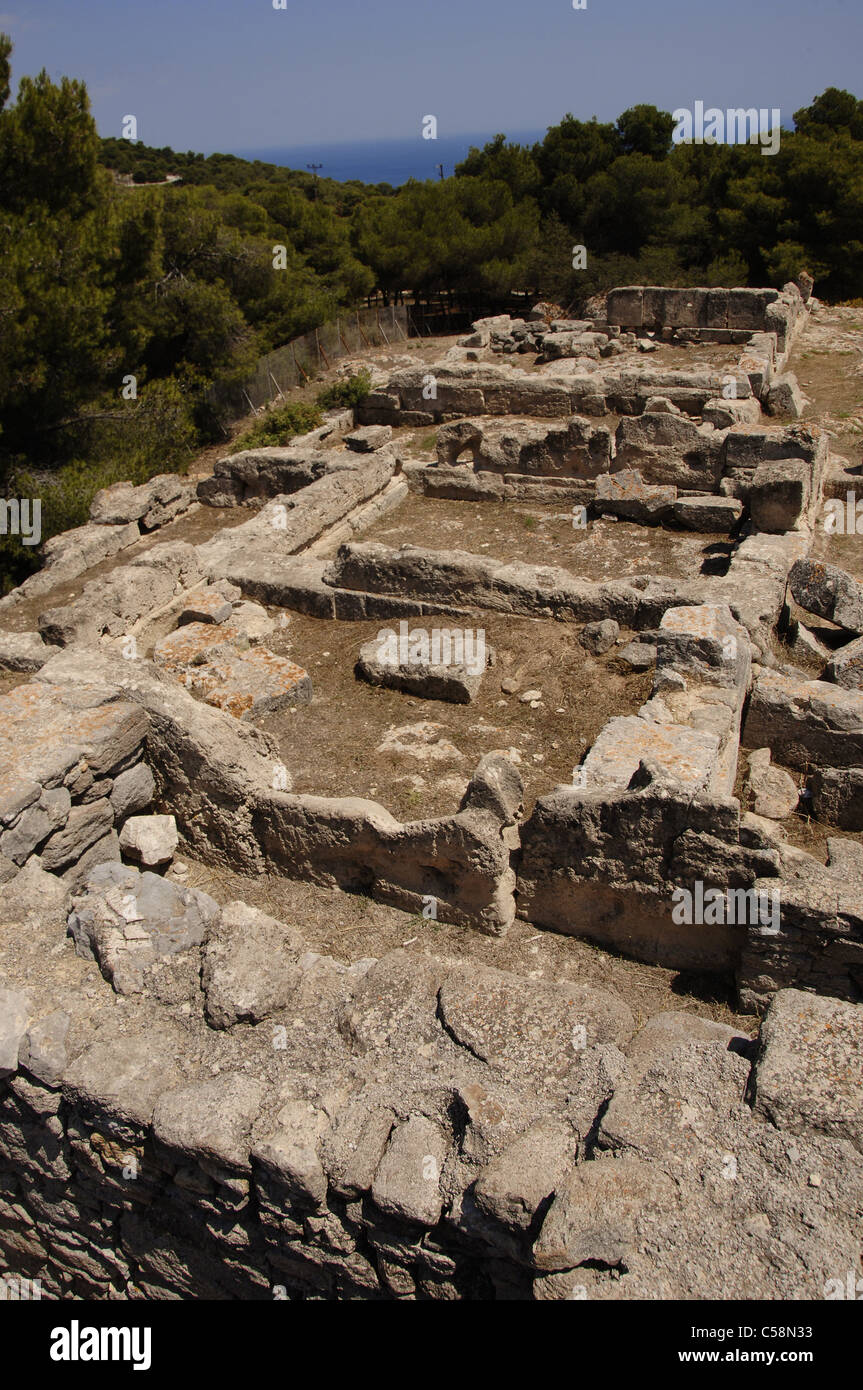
[{"left": 260, "top": 613, "right": 650, "bottom": 820}]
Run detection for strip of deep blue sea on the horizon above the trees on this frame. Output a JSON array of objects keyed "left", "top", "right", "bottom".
[{"left": 230, "top": 131, "right": 545, "bottom": 188}]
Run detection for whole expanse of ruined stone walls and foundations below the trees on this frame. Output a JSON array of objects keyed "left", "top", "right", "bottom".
[{"left": 0, "top": 279, "right": 863, "bottom": 1300}]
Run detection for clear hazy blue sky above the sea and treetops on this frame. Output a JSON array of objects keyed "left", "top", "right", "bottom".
[{"left": 0, "top": 0, "right": 863, "bottom": 153}]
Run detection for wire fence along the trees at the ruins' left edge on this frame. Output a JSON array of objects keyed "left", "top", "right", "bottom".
[{"left": 211, "top": 304, "right": 418, "bottom": 420}]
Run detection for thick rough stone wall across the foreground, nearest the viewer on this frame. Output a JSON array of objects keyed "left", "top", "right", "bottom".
[{"left": 0, "top": 870, "right": 863, "bottom": 1300}]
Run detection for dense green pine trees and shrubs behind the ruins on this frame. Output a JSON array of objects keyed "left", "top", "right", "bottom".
[{"left": 0, "top": 27, "right": 863, "bottom": 582}]
